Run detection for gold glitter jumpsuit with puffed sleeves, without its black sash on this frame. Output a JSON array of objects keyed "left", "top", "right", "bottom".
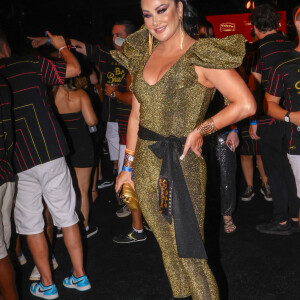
[{"left": 111, "top": 28, "right": 245, "bottom": 300}]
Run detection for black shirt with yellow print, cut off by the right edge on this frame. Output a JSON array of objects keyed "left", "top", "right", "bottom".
[{"left": 266, "top": 50, "right": 300, "bottom": 155}]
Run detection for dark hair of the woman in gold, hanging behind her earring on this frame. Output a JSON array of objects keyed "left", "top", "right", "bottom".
[{"left": 174, "top": 0, "right": 198, "bottom": 38}]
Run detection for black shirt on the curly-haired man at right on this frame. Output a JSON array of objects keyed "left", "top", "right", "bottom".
[{"left": 252, "top": 33, "right": 295, "bottom": 125}]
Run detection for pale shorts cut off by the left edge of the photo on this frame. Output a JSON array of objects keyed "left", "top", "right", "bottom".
[{"left": 0, "top": 182, "right": 15, "bottom": 259}]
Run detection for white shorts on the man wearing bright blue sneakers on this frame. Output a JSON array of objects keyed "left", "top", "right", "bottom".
[{"left": 14, "top": 157, "right": 78, "bottom": 235}]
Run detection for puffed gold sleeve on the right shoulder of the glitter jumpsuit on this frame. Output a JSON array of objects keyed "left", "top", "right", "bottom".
[{"left": 188, "top": 35, "right": 245, "bottom": 69}]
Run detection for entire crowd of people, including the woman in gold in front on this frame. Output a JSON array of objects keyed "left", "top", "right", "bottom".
[{"left": 0, "top": 0, "right": 300, "bottom": 300}]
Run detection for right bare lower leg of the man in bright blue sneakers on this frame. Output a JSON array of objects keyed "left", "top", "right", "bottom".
[{"left": 62, "top": 224, "right": 85, "bottom": 278}]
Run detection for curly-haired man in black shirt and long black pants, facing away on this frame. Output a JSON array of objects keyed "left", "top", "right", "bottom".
[{"left": 249, "top": 4, "right": 297, "bottom": 235}]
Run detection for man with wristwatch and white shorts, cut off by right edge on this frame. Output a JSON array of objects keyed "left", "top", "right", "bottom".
[{"left": 265, "top": 6, "right": 300, "bottom": 231}]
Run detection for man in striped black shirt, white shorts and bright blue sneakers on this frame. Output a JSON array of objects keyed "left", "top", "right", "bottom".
[{"left": 0, "top": 29, "right": 90, "bottom": 299}]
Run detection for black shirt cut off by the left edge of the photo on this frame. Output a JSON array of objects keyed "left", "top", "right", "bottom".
[{"left": 0, "top": 75, "right": 14, "bottom": 185}]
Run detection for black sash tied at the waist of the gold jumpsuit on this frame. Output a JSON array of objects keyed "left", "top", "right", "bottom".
[{"left": 138, "top": 126, "right": 207, "bottom": 259}]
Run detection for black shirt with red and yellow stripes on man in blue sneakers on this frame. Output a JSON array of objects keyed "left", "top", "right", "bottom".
[{"left": 0, "top": 57, "right": 68, "bottom": 173}]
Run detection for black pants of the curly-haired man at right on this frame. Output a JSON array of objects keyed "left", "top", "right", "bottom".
[{"left": 257, "top": 122, "right": 299, "bottom": 222}]
